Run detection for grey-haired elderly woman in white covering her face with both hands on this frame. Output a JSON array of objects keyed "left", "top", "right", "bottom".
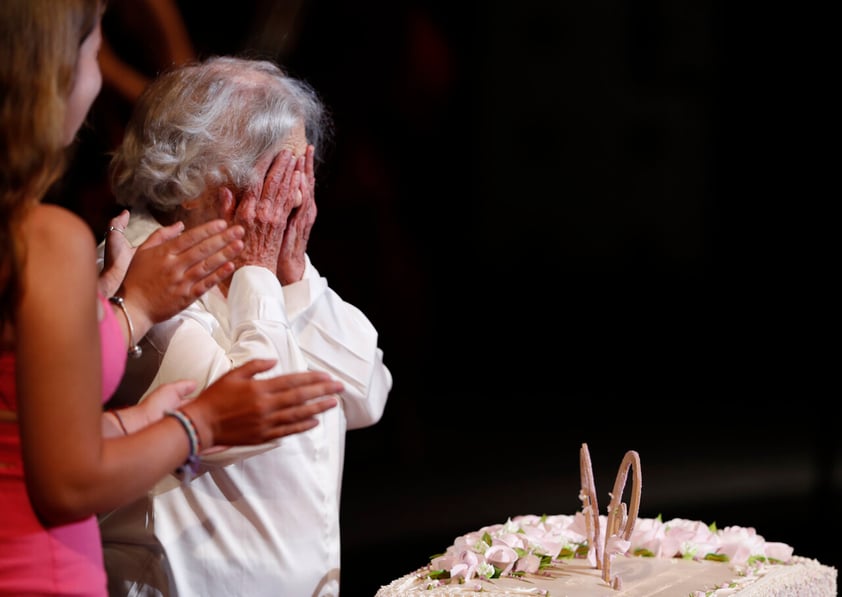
[{"left": 102, "top": 57, "right": 392, "bottom": 597}]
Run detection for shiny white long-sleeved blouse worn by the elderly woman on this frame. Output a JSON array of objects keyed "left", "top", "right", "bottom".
[{"left": 100, "top": 207, "right": 392, "bottom": 597}]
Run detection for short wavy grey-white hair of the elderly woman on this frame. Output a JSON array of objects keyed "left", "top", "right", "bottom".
[{"left": 111, "top": 56, "right": 331, "bottom": 212}]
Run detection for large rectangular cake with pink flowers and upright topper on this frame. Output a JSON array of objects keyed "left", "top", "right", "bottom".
[{"left": 376, "top": 444, "right": 837, "bottom": 597}]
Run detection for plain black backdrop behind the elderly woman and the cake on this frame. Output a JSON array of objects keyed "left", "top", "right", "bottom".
[{"left": 60, "top": 0, "right": 842, "bottom": 597}]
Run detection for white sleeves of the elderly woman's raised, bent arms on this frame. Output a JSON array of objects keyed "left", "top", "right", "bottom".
[{"left": 144, "top": 260, "right": 392, "bottom": 429}]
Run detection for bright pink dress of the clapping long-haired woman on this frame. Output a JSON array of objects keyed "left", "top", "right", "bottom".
[{"left": 0, "top": 297, "right": 126, "bottom": 597}]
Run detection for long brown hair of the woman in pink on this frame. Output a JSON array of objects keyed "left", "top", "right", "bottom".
[{"left": 0, "top": 0, "right": 102, "bottom": 338}]
